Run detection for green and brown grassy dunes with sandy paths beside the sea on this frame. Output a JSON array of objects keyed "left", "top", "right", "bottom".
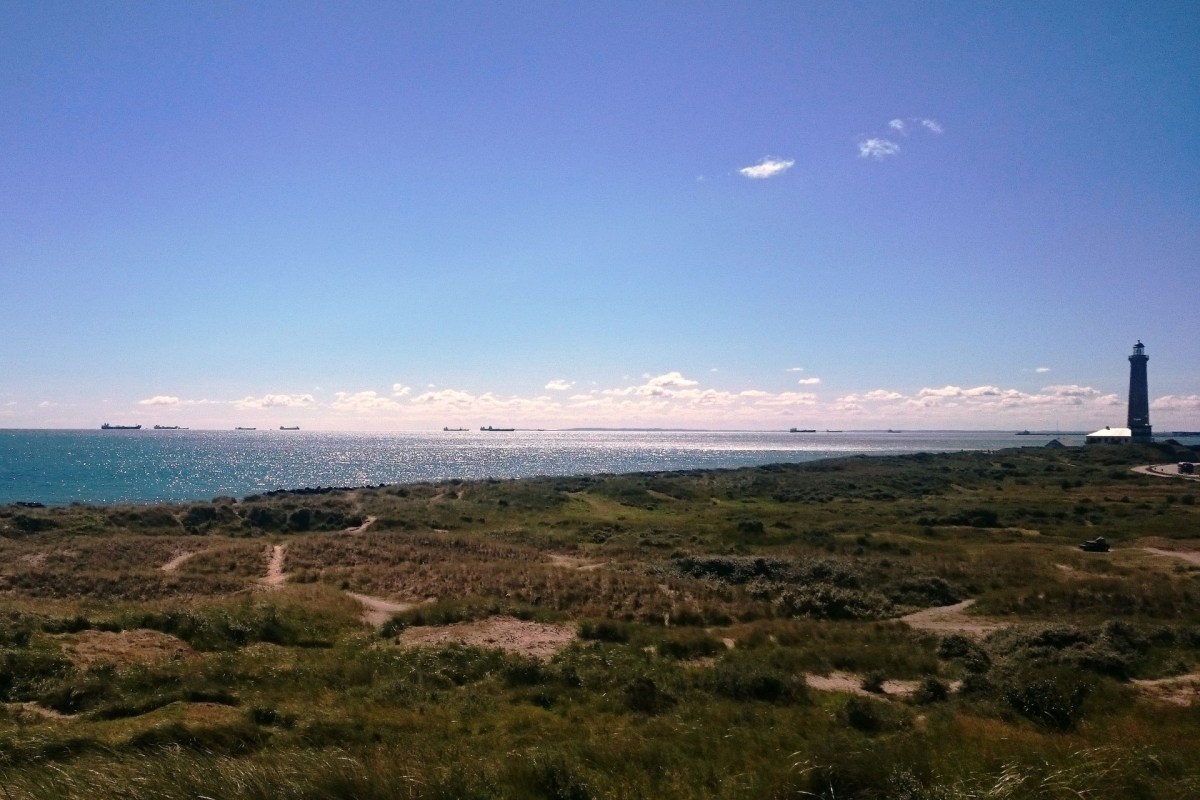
[{"left": 0, "top": 445, "right": 1200, "bottom": 800}]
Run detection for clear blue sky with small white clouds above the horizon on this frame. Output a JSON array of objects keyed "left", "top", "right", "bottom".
[{"left": 0, "top": 0, "right": 1200, "bottom": 431}]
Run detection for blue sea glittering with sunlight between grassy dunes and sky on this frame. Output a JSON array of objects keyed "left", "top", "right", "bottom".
[{"left": 0, "top": 429, "right": 1082, "bottom": 505}]
